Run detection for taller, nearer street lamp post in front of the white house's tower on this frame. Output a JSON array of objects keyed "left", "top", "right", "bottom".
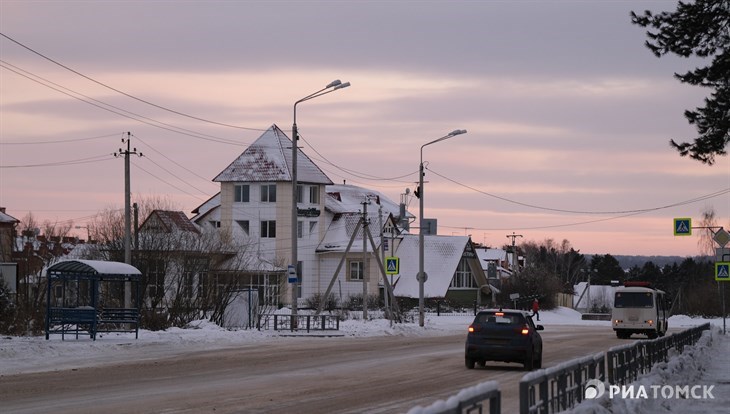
[{"left": 290, "top": 79, "right": 350, "bottom": 330}]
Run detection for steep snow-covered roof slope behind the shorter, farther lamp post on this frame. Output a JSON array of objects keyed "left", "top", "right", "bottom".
[{"left": 394, "top": 234, "right": 469, "bottom": 298}]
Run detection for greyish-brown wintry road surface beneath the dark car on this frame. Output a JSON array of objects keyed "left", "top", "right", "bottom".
[{"left": 0, "top": 326, "right": 632, "bottom": 414}]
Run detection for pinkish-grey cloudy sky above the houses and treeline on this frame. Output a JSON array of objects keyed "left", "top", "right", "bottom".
[{"left": 0, "top": 0, "right": 730, "bottom": 256}]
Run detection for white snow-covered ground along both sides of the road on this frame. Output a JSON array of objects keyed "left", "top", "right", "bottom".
[{"left": 0, "top": 308, "right": 730, "bottom": 414}]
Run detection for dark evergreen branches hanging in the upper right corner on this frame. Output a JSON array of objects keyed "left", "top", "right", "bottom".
[{"left": 631, "top": 0, "right": 730, "bottom": 165}]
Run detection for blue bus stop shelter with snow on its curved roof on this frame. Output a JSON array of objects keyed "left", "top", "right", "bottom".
[{"left": 46, "top": 260, "right": 142, "bottom": 340}]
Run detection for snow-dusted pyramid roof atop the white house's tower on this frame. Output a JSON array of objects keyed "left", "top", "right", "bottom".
[{"left": 213, "top": 125, "right": 332, "bottom": 184}]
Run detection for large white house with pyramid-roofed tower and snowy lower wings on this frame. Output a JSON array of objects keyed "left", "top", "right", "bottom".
[{"left": 192, "top": 125, "right": 489, "bottom": 304}]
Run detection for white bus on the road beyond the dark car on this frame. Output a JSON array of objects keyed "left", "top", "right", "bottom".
[{"left": 611, "top": 282, "right": 669, "bottom": 339}]
